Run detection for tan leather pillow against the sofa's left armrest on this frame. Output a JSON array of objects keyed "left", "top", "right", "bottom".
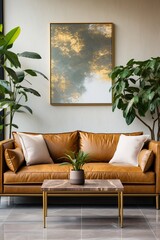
[{"left": 5, "top": 148, "right": 24, "bottom": 172}]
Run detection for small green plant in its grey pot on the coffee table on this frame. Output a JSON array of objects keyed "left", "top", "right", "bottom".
[{"left": 61, "top": 151, "right": 88, "bottom": 185}]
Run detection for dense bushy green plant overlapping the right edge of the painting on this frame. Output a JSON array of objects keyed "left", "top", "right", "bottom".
[{"left": 110, "top": 57, "right": 160, "bottom": 140}]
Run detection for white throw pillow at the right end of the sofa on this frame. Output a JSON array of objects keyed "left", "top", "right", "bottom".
[{"left": 109, "top": 134, "right": 149, "bottom": 166}]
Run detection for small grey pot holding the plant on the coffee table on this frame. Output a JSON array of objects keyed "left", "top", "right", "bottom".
[{"left": 70, "top": 170, "right": 85, "bottom": 185}]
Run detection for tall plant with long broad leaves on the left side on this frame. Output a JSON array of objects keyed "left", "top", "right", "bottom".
[{"left": 0, "top": 25, "right": 47, "bottom": 137}]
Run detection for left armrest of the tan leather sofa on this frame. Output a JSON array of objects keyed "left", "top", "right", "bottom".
[{"left": 0, "top": 139, "right": 14, "bottom": 194}]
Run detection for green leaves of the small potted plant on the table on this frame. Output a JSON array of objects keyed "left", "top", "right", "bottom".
[{"left": 61, "top": 151, "right": 88, "bottom": 171}]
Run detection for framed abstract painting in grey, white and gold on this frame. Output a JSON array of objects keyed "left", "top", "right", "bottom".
[{"left": 50, "top": 23, "right": 113, "bottom": 105}]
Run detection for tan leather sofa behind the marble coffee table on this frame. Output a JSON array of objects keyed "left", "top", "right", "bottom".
[{"left": 0, "top": 131, "right": 160, "bottom": 209}]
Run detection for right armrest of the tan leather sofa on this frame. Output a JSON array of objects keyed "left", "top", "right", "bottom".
[{"left": 148, "top": 140, "right": 160, "bottom": 194}]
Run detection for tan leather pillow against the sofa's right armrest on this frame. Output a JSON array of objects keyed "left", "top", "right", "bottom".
[{"left": 138, "top": 149, "right": 154, "bottom": 172}]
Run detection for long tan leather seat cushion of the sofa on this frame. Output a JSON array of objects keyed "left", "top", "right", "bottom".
[{"left": 4, "top": 163, "right": 155, "bottom": 184}]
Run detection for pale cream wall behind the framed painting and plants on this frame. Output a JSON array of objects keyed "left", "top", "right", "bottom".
[{"left": 4, "top": 0, "right": 160, "bottom": 136}]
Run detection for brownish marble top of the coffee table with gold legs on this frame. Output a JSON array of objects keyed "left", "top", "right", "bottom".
[{"left": 41, "top": 179, "right": 124, "bottom": 192}]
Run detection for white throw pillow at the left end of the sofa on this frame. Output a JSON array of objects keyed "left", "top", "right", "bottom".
[{"left": 17, "top": 132, "right": 53, "bottom": 165}]
